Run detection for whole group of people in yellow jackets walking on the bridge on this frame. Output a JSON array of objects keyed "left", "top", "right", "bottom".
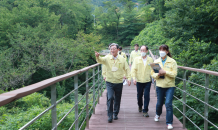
[{"left": 95, "top": 43, "right": 177, "bottom": 129}]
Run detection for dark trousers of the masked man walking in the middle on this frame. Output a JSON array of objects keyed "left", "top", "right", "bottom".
[{"left": 136, "top": 82, "right": 151, "bottom": 112}]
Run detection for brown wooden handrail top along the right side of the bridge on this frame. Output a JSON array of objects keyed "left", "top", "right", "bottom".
[{"left": 149, "top": 50, "right": 218, "bottom": 76}]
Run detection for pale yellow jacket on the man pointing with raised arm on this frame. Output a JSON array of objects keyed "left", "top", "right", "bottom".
[{"left": 96, "top": 55, "right": 131, "bottom": 83}]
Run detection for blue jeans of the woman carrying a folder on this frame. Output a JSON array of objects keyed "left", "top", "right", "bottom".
[{"left": 156, "top": 86, "right": 175, "bottom": 125}]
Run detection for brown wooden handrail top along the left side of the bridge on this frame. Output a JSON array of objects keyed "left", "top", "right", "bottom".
[{"left": 0, "top": 64, "right": 100, "bottom": 107}]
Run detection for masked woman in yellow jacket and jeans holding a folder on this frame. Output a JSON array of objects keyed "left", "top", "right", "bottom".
[{"left": 151, "top": 45, "right": 177, "bottom": 129}]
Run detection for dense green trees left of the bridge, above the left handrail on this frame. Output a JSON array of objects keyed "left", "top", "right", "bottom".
[{"left": 0, "top": 0, "right": 102, "bottom": 90}]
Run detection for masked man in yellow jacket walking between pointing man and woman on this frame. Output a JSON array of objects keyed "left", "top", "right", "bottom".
[{"left": 131, "top": 45, "right": 153, "bottom": 117}]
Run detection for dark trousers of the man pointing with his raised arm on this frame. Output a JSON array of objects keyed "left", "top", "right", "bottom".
[{"left": 106, "top": 82, "right": 123, "bottom": 117}]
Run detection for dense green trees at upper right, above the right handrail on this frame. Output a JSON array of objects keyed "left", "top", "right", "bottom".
[{"left": 132, "top": 0, "right": 218, "bottom": 68}]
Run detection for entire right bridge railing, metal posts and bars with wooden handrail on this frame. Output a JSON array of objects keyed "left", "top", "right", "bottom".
[{"left": 149, "top": 49, "right": 218, "bottom": 130}]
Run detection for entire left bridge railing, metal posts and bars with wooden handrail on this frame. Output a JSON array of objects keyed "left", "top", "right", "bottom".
[{"left": 0, "top": 64, "right": 105, "bottom": 130}]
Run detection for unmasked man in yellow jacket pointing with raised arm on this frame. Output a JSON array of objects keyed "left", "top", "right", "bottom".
[{"left": 95, "top": 43, "right": 131, "bottom": 123}]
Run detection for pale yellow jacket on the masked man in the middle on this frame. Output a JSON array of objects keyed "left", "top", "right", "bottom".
[{"left": 131, "top": 56, "right": 154, "bottom": 83}]
